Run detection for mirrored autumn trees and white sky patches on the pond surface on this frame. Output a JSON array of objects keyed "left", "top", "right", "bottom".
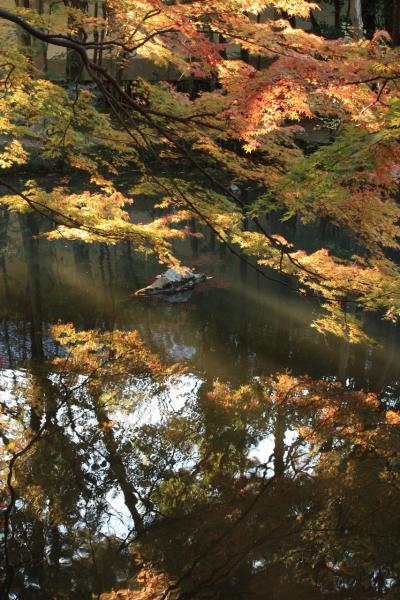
[{"left": 1, "top": 325, "right": 400, "bottom": 600}]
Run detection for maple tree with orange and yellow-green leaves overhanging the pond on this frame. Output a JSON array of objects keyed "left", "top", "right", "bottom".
[{"left": 0, "top": 0, "right": 400, "bottom": 342}]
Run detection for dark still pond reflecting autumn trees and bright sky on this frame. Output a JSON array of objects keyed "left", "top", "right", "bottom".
[{"left": 0, "top": 206, "right": 400, "bottom": 600}]
